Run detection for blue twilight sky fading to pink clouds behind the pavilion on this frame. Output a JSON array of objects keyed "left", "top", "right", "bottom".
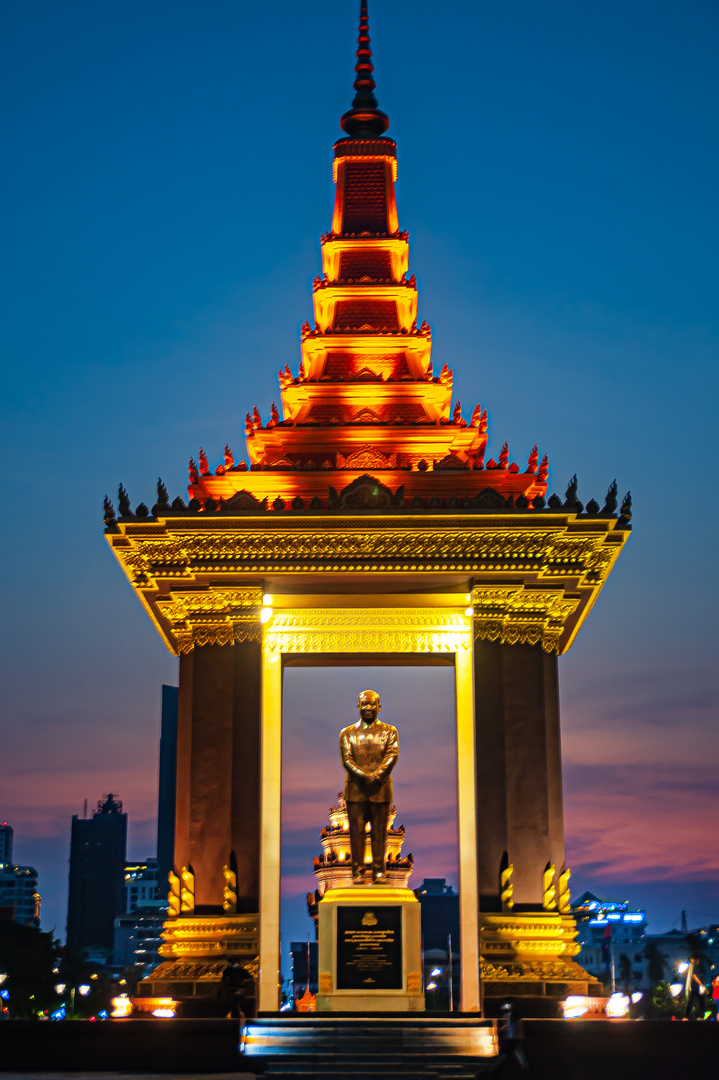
[{"left": 0, "top": 0, "right": 719, "bottom": 940}]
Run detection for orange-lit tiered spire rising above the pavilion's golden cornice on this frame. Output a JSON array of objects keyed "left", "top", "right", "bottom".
[{"left": 189, "top": 0, "right": 547, "bottom": 510}]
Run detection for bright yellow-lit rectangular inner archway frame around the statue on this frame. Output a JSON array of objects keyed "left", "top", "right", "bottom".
[{"left": 259, "top": 595, "right": 479, "bottom": 1012}]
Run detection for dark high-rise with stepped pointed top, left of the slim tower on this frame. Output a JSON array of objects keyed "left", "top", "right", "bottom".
[{"left": 67, "top": 794, "right": 127, "bottom": 956}]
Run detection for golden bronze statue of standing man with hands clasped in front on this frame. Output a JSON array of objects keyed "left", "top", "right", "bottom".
[{"left": 340, "top": 690, "right": 399, "bottom": 885}]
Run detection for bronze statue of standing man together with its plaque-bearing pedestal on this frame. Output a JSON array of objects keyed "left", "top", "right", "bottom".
[{"left": 317, "top": 690, "right": 424, "bottom": 1013}]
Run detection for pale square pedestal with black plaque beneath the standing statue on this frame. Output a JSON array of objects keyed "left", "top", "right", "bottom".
[{"left": 317, "top": 885, "right": 424, "bottom": 1013}]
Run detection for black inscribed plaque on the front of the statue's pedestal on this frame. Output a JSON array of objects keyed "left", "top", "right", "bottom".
[{"left": 337, "top": 905, "right": 403, "bottom": 990}]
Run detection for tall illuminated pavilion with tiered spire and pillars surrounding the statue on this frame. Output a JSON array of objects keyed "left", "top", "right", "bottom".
[{"left": 105, "top": 2, "right": 630, "bottom": 1012}]
